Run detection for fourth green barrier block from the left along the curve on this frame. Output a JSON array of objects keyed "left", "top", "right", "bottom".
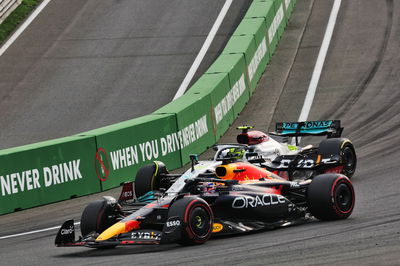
[{"left": 186, "top": 73, "right": 234, "bottom": 141}]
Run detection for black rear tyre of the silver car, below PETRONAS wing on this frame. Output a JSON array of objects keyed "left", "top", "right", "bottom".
[{"left": 318, "top": 138, "right": 357, "bottom": 178}]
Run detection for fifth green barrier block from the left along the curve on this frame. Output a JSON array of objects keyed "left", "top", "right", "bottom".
[{"left": 206, "top": 54, "right": 250, "bottom": 120}]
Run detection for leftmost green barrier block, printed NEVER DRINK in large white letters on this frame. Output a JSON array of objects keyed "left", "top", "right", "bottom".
[{"left": 0, "top": 136, "right": 100, "bottom": 214}]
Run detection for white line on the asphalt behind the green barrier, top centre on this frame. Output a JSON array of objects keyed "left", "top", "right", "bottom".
[{"left": 174, "top": 0, "right": 233, "bottom": 100}]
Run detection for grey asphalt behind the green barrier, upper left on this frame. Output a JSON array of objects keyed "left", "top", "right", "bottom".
[{"left": 0, "top": 0, "right": 250, "bottom": 149}]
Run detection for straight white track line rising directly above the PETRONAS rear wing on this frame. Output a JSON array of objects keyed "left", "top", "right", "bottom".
[{"left": 292, "top": 0, "right": 342, "bottom": 143}]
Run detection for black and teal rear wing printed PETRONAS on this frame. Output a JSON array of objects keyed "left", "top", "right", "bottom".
[{"left": 270, "top": 120, "right": 343, "bottom": 143}]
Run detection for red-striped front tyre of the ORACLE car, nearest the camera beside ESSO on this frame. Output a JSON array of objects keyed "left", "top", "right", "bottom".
[{"left": 168, "top": 197, "right": 214, "bottom": 246}]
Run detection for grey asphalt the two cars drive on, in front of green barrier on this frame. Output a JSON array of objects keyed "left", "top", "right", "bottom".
[{"left": 0, "top": 0, "right": 400, "bottom": 265}]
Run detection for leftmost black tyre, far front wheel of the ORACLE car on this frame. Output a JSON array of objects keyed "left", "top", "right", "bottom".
[{"left": 81, "top": 200, "right": 117, "bottom": 236}]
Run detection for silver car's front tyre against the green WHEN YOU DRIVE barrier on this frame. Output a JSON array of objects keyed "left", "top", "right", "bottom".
[{"left": 135, "top": 161, "right": 168, "bottom": 198}]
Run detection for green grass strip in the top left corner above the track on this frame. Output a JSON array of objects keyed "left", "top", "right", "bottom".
[{"left": 0, "top": 0, "right": 41, "bottom": 46}]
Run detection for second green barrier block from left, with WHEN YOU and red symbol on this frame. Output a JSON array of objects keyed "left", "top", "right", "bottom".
[{"left": 80, "top": 114, "right": 181, "bottom": 190}]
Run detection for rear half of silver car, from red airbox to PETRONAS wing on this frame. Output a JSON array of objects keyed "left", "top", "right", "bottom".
[{"left": 237, "top": 120, "right": 357, "bottom": 180}]
